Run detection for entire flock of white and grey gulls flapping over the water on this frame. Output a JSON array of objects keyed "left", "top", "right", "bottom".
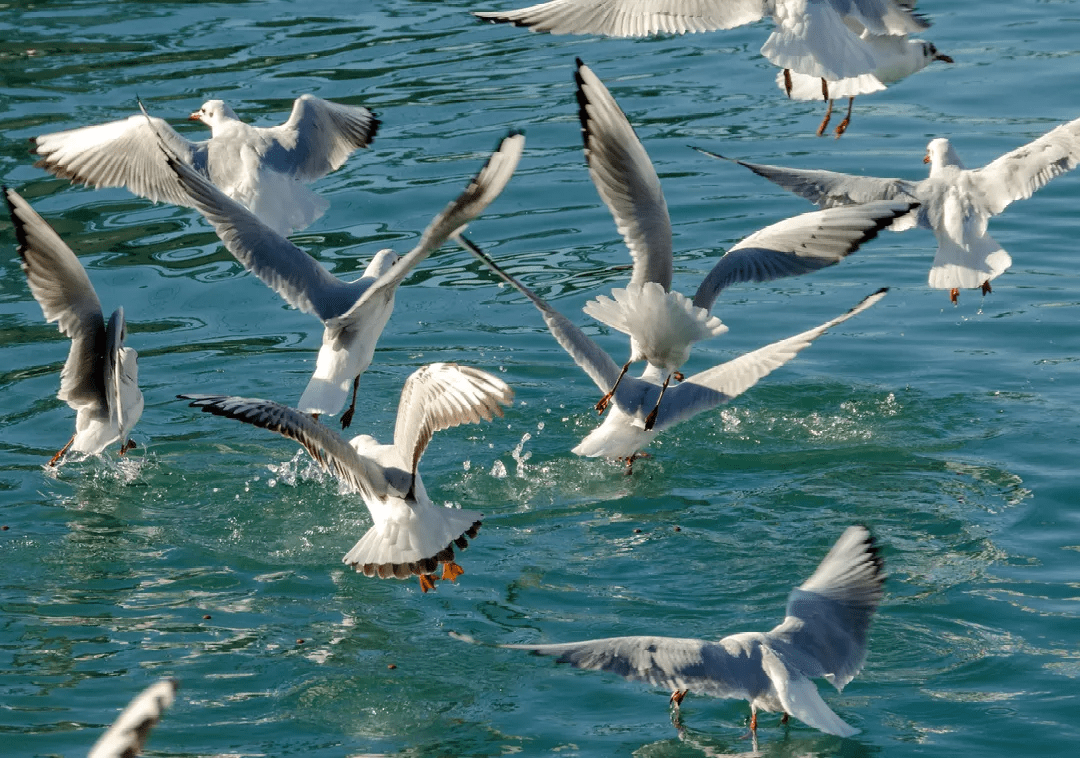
[{"left": 4, "top": 0, "right": 1080, "bottom": 758}]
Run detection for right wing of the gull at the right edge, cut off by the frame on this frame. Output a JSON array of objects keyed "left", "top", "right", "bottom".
[{"left": 970, "top": 119, "right": 1080, "bottom": 216}]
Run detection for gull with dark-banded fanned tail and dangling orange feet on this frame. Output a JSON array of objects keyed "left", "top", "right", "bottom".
[{"left": 177, "top": 363, "right": 514, "bottom": 592}]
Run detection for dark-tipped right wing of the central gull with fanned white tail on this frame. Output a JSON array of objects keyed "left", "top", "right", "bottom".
[{"left": 693, "top": 200, "right": 918, "bottom": 310}]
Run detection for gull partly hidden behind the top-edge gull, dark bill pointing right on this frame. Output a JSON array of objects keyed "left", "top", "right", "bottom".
[{"left": 777, "top": 29, "right": 953, "bottom": 139}]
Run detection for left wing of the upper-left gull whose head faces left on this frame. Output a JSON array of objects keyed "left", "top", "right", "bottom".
[{"left": 33, "top": 114, "right": 206, "bottom": 207}]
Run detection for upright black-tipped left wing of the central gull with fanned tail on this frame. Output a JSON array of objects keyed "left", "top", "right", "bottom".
[{"left": 573, "top": 58, "right": 672, "bottom": 289}]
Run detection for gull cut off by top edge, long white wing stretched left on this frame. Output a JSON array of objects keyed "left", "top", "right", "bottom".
[{"left": 473, "top": 0, "right": 930, "bottom": 120}]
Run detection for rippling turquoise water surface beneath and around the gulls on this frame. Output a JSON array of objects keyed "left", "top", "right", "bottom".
[{"left": 0, "top": 0, "right": 1080, "bottom": 758}]
